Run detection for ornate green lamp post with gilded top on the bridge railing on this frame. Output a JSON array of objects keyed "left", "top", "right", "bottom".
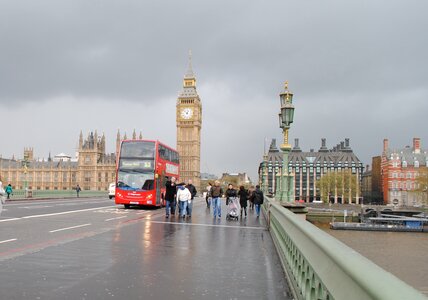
[{"left": 277, "top": 81, "right": 294, "bottom": 203}]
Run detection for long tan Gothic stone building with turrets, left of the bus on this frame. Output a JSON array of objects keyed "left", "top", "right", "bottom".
[{"left": 0, "top": 131, "right": 142, "bottom": 191}]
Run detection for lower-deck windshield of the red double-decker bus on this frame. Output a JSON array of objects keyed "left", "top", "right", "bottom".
[{"left": 117, "top": 170, "right": 155, "bottom": 191}]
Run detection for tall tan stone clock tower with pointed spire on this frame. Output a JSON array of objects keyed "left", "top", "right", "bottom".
[{"left": 177, "top": 53, "right": 202, "bottom": 192}]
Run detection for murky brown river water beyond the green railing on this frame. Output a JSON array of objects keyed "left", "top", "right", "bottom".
[{"left": 320, "top": 226, "right": 428, "bottom": 296}]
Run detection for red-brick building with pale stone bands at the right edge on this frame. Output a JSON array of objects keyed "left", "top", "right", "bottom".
[{"left": 381, "top": 138, "right": 428, "bottom": 206}]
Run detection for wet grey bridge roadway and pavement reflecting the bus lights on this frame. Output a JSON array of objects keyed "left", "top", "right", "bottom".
[{"left": 0, "top": 198, "right": 291, "bottom": 300}]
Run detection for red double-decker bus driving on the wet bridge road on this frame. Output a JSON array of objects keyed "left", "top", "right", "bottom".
[{"left": 115, "top": 140, "right": 180, "bottom": 208}]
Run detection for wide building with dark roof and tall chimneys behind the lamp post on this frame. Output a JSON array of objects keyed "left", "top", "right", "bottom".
[{"left": 258, "top": 139, "right": 364, "bottom": 203}]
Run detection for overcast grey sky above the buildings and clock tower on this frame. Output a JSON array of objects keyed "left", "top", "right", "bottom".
[{"left": 0, "top": 0, "right": 428, "bottom": 179}]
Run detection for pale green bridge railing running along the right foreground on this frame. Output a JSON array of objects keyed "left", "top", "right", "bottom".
[{"left": 263, "top": 198, "right": 427, "bottom": 300}]
